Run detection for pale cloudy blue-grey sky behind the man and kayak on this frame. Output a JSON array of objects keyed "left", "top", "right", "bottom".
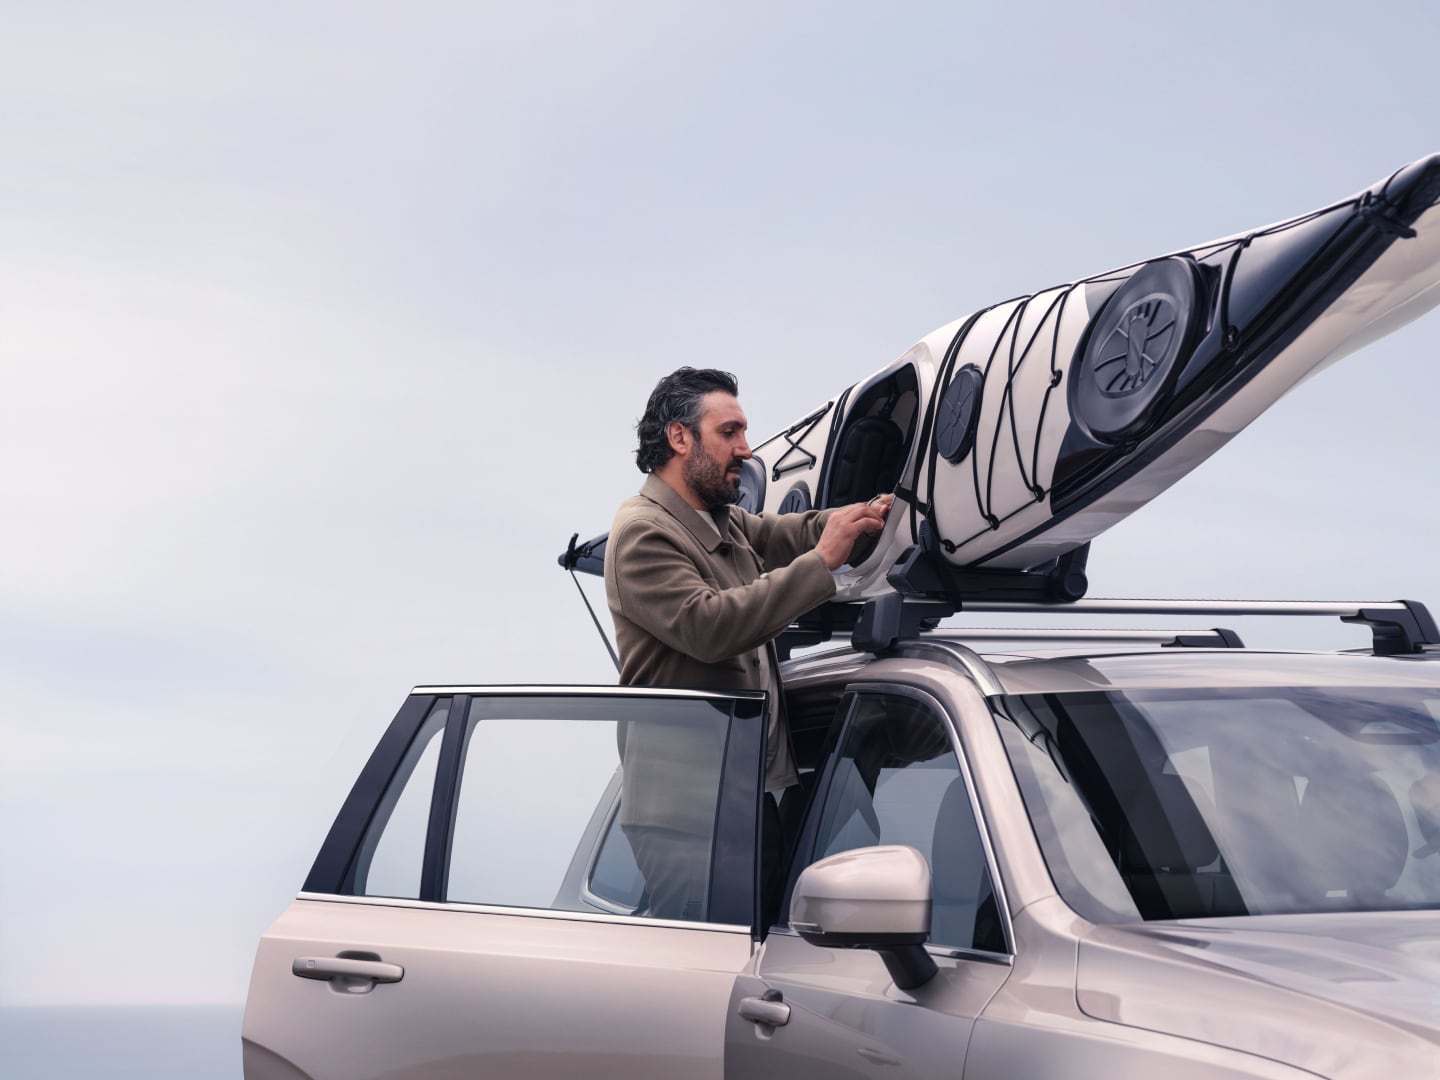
[{"left": 0, "top": 0, "right": 1440, "bottom": 1007}]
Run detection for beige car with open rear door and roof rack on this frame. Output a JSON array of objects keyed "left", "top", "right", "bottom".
[{"left": 242, "top": 593, "right": 1440, "bottom": 1080}]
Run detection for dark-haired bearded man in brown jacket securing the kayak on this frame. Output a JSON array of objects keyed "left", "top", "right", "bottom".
[{"left": 605, "top": 367, "right": 891, "bottom": 917}]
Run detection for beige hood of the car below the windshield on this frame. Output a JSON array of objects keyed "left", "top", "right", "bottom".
[{"left": 1076, "top": 912, "right": 1440, "bottom": 1077}]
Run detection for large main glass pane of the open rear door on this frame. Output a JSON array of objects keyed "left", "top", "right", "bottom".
[{"left": 445, "top": 698, "right": 730, "bottom": 922}]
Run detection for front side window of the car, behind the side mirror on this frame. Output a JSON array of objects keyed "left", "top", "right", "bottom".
[{"left": 812, "top": 694, "right": 1005, "bottom": 952}]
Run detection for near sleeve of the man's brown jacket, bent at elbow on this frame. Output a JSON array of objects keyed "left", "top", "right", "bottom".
[{"left": 606, "top": 521, "right": 835, "bottom": 664}]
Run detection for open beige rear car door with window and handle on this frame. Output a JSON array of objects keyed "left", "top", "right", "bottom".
[{"left": 243, "top": 687, "right": 765, "bottom": 1080}]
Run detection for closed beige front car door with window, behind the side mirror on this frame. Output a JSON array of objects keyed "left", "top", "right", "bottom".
[{"left": 726, "top": 684, "right": 1014, "bottom": 1080}]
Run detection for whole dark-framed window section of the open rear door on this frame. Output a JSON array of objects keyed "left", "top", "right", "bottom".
[{"left": 321, "top": 688, "right": 765, "bottom": 929}]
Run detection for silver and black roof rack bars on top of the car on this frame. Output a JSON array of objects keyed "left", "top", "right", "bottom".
[{"left": 778, "top": 593, "right": 1440, "bottom": 657}]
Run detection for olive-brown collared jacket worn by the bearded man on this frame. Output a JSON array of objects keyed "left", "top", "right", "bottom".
[{"left": 605, "top": 475, "right": 835, "bottom": 690}]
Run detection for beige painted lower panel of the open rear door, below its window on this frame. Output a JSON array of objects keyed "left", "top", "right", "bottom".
[{"left": 245, "top": 900, "right": 752, "bottom": 1080}]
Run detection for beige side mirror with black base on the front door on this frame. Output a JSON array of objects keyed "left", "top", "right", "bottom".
[{"left": 791, "top": 844, "right": 936, "bottom": 989}]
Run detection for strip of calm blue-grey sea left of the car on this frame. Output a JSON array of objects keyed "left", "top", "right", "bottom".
[{"left": 0, "top": 1005, "right": 245, "bottom": 1080}]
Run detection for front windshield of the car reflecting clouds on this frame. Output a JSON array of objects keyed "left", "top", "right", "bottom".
[{"left": 996, "top": 687, "right": 1440, "bottom": 922}]
